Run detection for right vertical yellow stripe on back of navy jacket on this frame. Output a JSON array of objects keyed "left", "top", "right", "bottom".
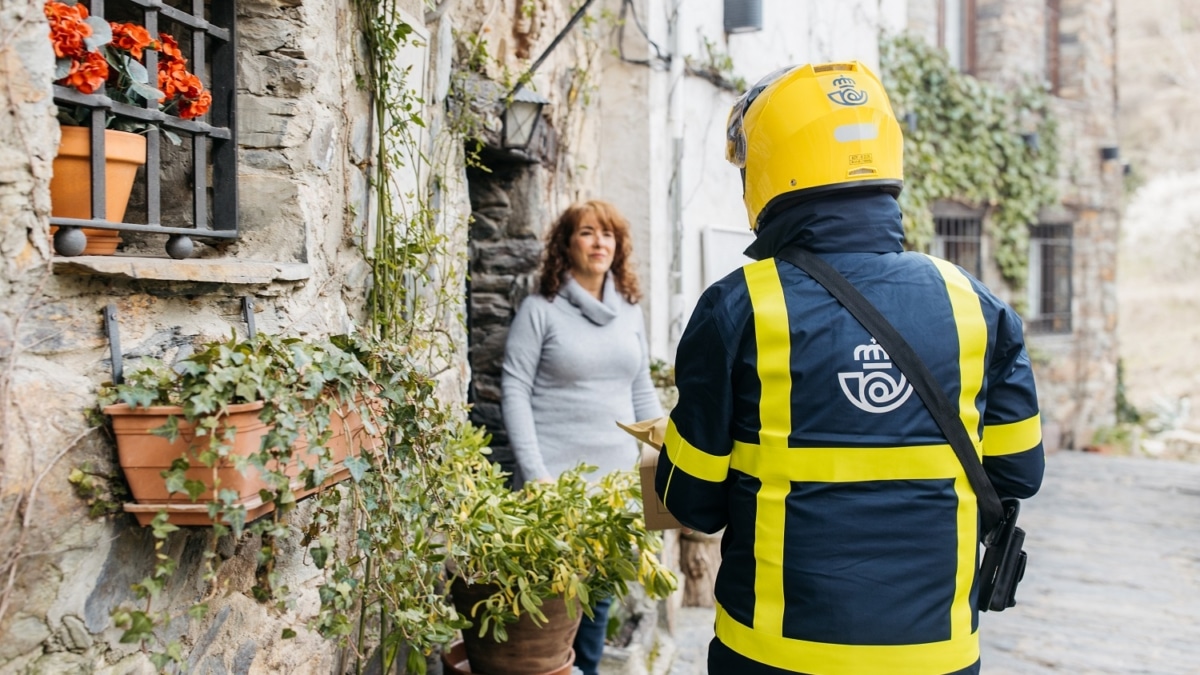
[{"left": 930, "top": 257, "right": 988, "bottom": 640}]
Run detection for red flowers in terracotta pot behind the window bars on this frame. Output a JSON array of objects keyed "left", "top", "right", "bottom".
[{"left": 43, "top": 0, "right": 212, "bottom": 255}]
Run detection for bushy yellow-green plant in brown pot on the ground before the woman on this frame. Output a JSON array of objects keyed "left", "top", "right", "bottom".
[{"left": 448, "top": 465, "right": 676, "bottom": 675}]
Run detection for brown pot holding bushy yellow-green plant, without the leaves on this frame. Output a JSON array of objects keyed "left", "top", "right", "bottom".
[{"left": 450, "top": 579, "right": 583, "bottom": 675}]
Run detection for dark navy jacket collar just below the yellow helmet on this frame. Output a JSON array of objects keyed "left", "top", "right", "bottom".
[{"left": 745, "top": 192, "right": 904, "bottom": 261}]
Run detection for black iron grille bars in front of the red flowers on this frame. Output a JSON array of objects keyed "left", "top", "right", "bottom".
[{"left": 50, "top": 0, "right": 238, "bottom": 258}]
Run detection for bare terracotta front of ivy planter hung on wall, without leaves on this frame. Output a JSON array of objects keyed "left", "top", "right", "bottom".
[{"left": 104, "top": 401, "right": 274, "bottom": 525}]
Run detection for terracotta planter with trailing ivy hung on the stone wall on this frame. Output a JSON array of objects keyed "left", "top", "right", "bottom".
[{"left": 102, "top": 336, "right": 382, "bottom": 527}]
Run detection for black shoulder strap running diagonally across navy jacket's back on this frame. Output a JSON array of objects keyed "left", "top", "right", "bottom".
[{"left": 775, "top": 246, "right": 1003, "bottom": 533}]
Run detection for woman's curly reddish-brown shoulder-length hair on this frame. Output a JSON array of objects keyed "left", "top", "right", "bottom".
[{"left": 538, "top": 199, "right": 642, "bottom": 304}]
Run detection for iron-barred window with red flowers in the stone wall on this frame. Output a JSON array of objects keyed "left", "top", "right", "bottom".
[{"left": 50, "top": 0, "right": 238, "bottom": 258}]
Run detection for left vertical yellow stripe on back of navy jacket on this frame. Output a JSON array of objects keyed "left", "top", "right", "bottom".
[{"left": 731, "top": 259, "right": 792, "bottom": 634}]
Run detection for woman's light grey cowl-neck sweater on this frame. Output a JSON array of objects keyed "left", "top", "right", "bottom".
[{"left": 502, "top": 275, "right": 662, "bottom": 485}]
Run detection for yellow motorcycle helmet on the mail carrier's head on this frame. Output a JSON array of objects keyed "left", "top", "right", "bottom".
[{"left": 725, "top": 61, "right": 904, "bottom": 232}]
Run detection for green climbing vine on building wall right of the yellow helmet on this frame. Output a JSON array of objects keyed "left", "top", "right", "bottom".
[{"left": 881, "top": 36, "right": 1058, "bottom": 288}]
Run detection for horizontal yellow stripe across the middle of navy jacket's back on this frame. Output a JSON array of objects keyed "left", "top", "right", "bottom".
[{"left": 730, "top": 441, "right": 966, "bottom": 480}]
